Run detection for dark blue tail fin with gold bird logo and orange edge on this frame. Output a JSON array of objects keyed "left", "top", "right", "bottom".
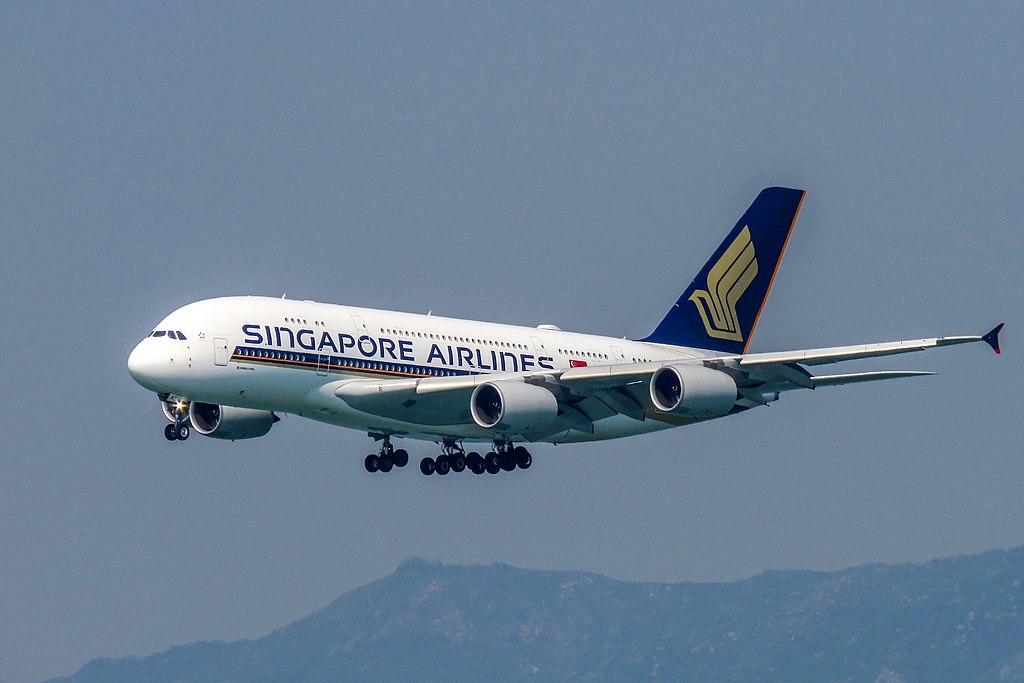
[{"left": 641, "top": 187, "right": 805, "bottom": 353}]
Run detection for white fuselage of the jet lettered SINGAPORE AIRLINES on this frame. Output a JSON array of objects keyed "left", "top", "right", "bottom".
[{"left": 128, "top": 296, "right": 712, "bottom": 443}]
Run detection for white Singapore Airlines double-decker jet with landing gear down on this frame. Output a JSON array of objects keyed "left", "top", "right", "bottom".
[{"left": 128, "top": 187, "right": 1002, "bottom": 475}]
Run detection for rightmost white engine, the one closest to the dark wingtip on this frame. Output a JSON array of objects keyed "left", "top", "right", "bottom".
[{"left": 650, "top": 365, "right": 737, "bottom": 418}]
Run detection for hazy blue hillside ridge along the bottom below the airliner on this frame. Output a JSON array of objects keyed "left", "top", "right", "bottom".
[{"left": 51, "top": 548, "right": 1024, "bottom": 683}]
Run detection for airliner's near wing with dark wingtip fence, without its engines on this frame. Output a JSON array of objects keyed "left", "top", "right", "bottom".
[{"left": 321, "top": 324, "right": 1002, "bottom": 438}]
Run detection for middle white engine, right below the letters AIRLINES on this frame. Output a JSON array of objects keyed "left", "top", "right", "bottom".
[{"left": 469, "top": 381, "right": 558, "bottom": 434}]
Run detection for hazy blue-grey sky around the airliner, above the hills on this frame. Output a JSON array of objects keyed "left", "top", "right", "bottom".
[{"left": 0, "top": 2, "right": 1024, "bottom": 682}]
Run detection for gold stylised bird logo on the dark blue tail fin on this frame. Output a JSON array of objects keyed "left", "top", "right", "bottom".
[{"left": 690, "top": 226, "right": 758, "bottom": 341}]
